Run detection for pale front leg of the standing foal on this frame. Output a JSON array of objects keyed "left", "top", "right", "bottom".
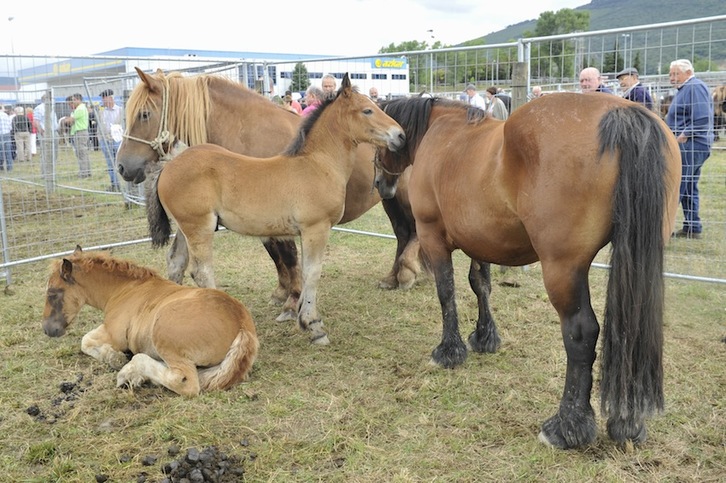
[{"left": 297, "top": 225, "right": 331, "bottom": 345}]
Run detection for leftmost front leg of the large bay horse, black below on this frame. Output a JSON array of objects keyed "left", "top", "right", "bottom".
[{"left": 430, "top": 248, "right": 466, "bottom": 369}]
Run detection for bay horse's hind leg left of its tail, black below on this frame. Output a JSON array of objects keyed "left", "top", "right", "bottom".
[{"left": 539, "top": 261, "right": 600, "bottom": 449}]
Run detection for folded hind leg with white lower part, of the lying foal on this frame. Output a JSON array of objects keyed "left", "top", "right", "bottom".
[{"left": 116, "top": 354, "right": 200, "bottom": 396}]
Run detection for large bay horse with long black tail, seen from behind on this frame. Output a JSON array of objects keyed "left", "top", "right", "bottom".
[{"left": 379, "top": 94, "right": 681, "bottom": 448}]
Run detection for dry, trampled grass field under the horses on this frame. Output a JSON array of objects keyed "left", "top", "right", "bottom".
[{"left": 0, "top": 146, "right": 726, "bottom": 482}]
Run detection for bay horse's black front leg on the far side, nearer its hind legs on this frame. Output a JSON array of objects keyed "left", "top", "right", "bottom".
[{"left": 469, "top": 260, "right": 501, "bottom": 353}]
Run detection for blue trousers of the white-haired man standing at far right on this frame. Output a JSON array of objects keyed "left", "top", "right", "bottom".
[{"left": 680, "top": 141, "right": 711, "bottom": 233}]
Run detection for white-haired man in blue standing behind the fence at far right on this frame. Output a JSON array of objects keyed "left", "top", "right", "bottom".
[{"left": 666, "top": 59, "right": 713, "bottom": 239}]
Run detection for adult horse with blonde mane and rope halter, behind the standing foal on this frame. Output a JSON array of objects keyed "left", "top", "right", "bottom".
[{"left": 118, "top": 68, "right": 421, "bottom": 318}]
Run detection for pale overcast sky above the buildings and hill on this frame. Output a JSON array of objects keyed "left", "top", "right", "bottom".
[{"left": 0, "top": 0, "right": 589, "bottom": 56}]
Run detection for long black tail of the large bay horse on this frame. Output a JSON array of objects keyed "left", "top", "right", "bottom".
[{"left": 600, "top": 106, "right": 670, "bottom": 439}]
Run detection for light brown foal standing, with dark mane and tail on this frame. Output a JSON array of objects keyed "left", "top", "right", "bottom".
[{"left": 147, "top": 74, "right": 405, "bottom": 344}]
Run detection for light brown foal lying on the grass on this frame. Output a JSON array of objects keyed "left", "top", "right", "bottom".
[{"left": 43, "top": 247, "right": 259, "bottom": 396}]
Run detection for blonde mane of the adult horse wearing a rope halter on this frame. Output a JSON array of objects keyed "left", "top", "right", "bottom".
[{"left": 126, "top": 72, "right": 233, "bottom": 146}]
